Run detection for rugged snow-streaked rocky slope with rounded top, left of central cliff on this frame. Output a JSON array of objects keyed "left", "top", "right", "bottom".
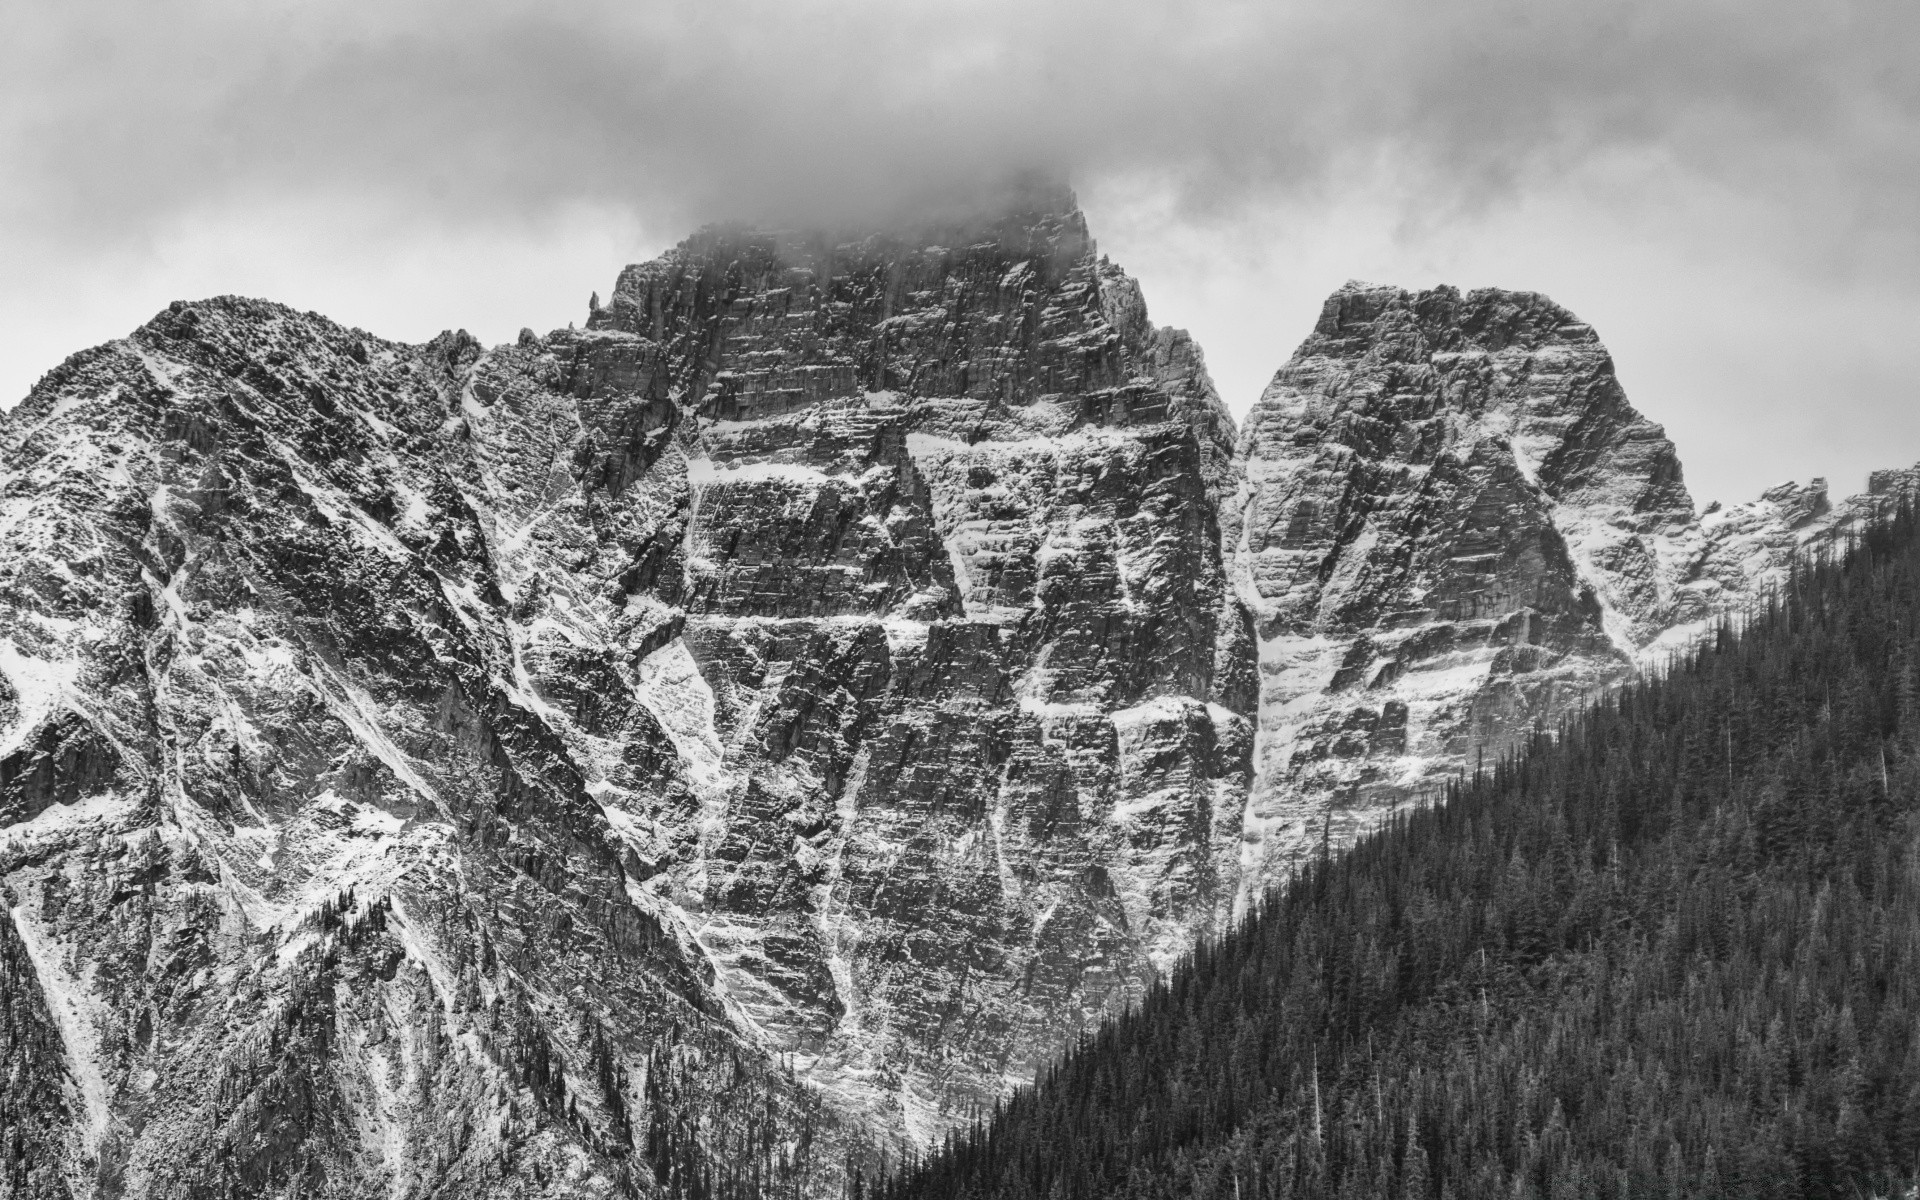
[{"left": 0, "top": 300, "right": 818, "bottom": 1196}]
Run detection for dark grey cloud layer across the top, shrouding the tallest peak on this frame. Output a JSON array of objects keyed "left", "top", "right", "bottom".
[{"left": 0, "top": 0, "right": 1920, "bottom": 261}]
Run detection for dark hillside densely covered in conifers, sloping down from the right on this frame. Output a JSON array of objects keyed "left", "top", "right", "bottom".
[{"left": 879, "top": 515, "right": 1920, "bottom": 1200}]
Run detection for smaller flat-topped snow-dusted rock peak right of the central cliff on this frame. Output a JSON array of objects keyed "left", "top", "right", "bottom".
[{"left": 1223, "top": 284, "right": 1914, "bottom": 900}]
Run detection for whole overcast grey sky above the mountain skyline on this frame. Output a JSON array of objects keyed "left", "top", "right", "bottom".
[{"left": 0, "top": 0, "right": 1920, "bottom": 503}]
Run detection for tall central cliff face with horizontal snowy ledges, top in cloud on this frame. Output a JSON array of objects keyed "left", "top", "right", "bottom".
[{"left": 568, "top": 193, "right": 1252, "bottom": 1140}]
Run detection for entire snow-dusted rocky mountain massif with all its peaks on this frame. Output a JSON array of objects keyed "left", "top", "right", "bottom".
[{"left": 0, "top": 190, "right": 1920, "bottom": 1198}]
